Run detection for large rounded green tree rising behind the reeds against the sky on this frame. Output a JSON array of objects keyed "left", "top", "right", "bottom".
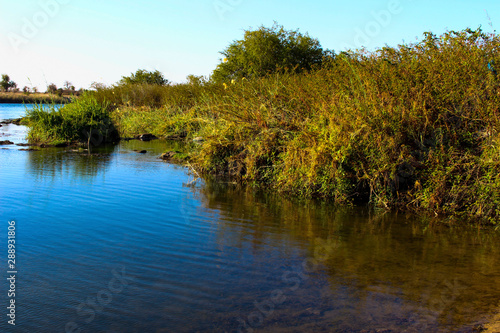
[{"left": 212, "top": 23, "right": 326, "bottom": 82}]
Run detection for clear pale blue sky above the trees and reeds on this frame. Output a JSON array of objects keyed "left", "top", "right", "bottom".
[{"left": 0, "top": 0, "right": 500, "bottom": 91}]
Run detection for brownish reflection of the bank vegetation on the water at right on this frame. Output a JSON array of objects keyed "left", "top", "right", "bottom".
[{"left": 190, "top": 182, "right": 500, "bottom": 332}]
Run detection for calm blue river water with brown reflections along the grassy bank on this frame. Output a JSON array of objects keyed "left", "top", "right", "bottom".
[{"left": 0, "top": 105, "right": 500, "bottom": 333}]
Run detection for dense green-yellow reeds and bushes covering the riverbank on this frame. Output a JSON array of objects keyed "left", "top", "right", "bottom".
[{"left": 25, "top": 27, "right": 500, "bottom": 223}]
